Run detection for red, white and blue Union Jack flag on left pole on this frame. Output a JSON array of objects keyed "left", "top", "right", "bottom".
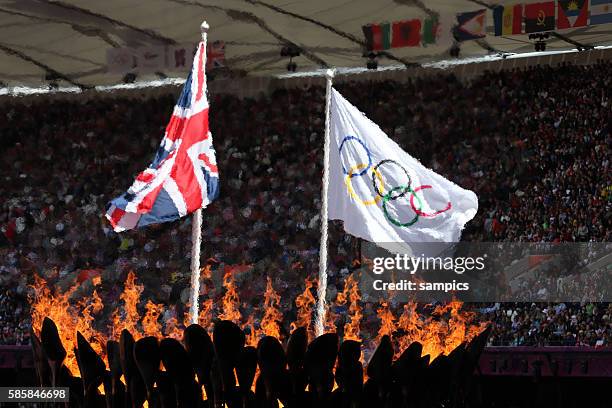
[{"left": 106, "top": 42, "right": 219, "bottom": 232}]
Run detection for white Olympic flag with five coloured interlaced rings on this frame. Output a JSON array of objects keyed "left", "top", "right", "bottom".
[{"left": 328, "top": 88, "right": 478, "bottom": 253}]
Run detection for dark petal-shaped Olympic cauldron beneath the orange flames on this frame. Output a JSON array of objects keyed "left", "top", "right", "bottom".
[{"left": 32, "top": 318, "right": 489, "bottom": 408}]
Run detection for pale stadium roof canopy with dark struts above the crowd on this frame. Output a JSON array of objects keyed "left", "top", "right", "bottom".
[{"left": 0, "top": 0, "right": 612, "bottom": 87}]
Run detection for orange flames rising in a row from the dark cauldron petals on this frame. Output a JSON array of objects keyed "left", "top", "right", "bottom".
[{"left": 30, "top": 268, "right": 485, "bottom": 375}]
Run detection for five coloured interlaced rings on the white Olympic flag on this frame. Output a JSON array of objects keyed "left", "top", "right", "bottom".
[{"left": 338, "top": 136, "right": 452, "bottom": 227}]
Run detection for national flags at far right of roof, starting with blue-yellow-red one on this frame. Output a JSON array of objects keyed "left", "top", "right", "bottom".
[{"left": 493, "top": 0, "right": 612, "bottom": 36}]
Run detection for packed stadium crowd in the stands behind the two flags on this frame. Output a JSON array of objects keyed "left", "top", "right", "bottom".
[{"left": 0, "top": 62, "right": 612, "bottom": 345}]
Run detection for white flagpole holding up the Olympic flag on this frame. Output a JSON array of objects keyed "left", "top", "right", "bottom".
[{"left": 315, "top": 69, "right": 335, "bottom": 337}]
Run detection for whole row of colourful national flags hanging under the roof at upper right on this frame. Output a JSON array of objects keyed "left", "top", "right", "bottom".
[{"left": 362, "top": 0, "right": 612, "bottom": 51}]
